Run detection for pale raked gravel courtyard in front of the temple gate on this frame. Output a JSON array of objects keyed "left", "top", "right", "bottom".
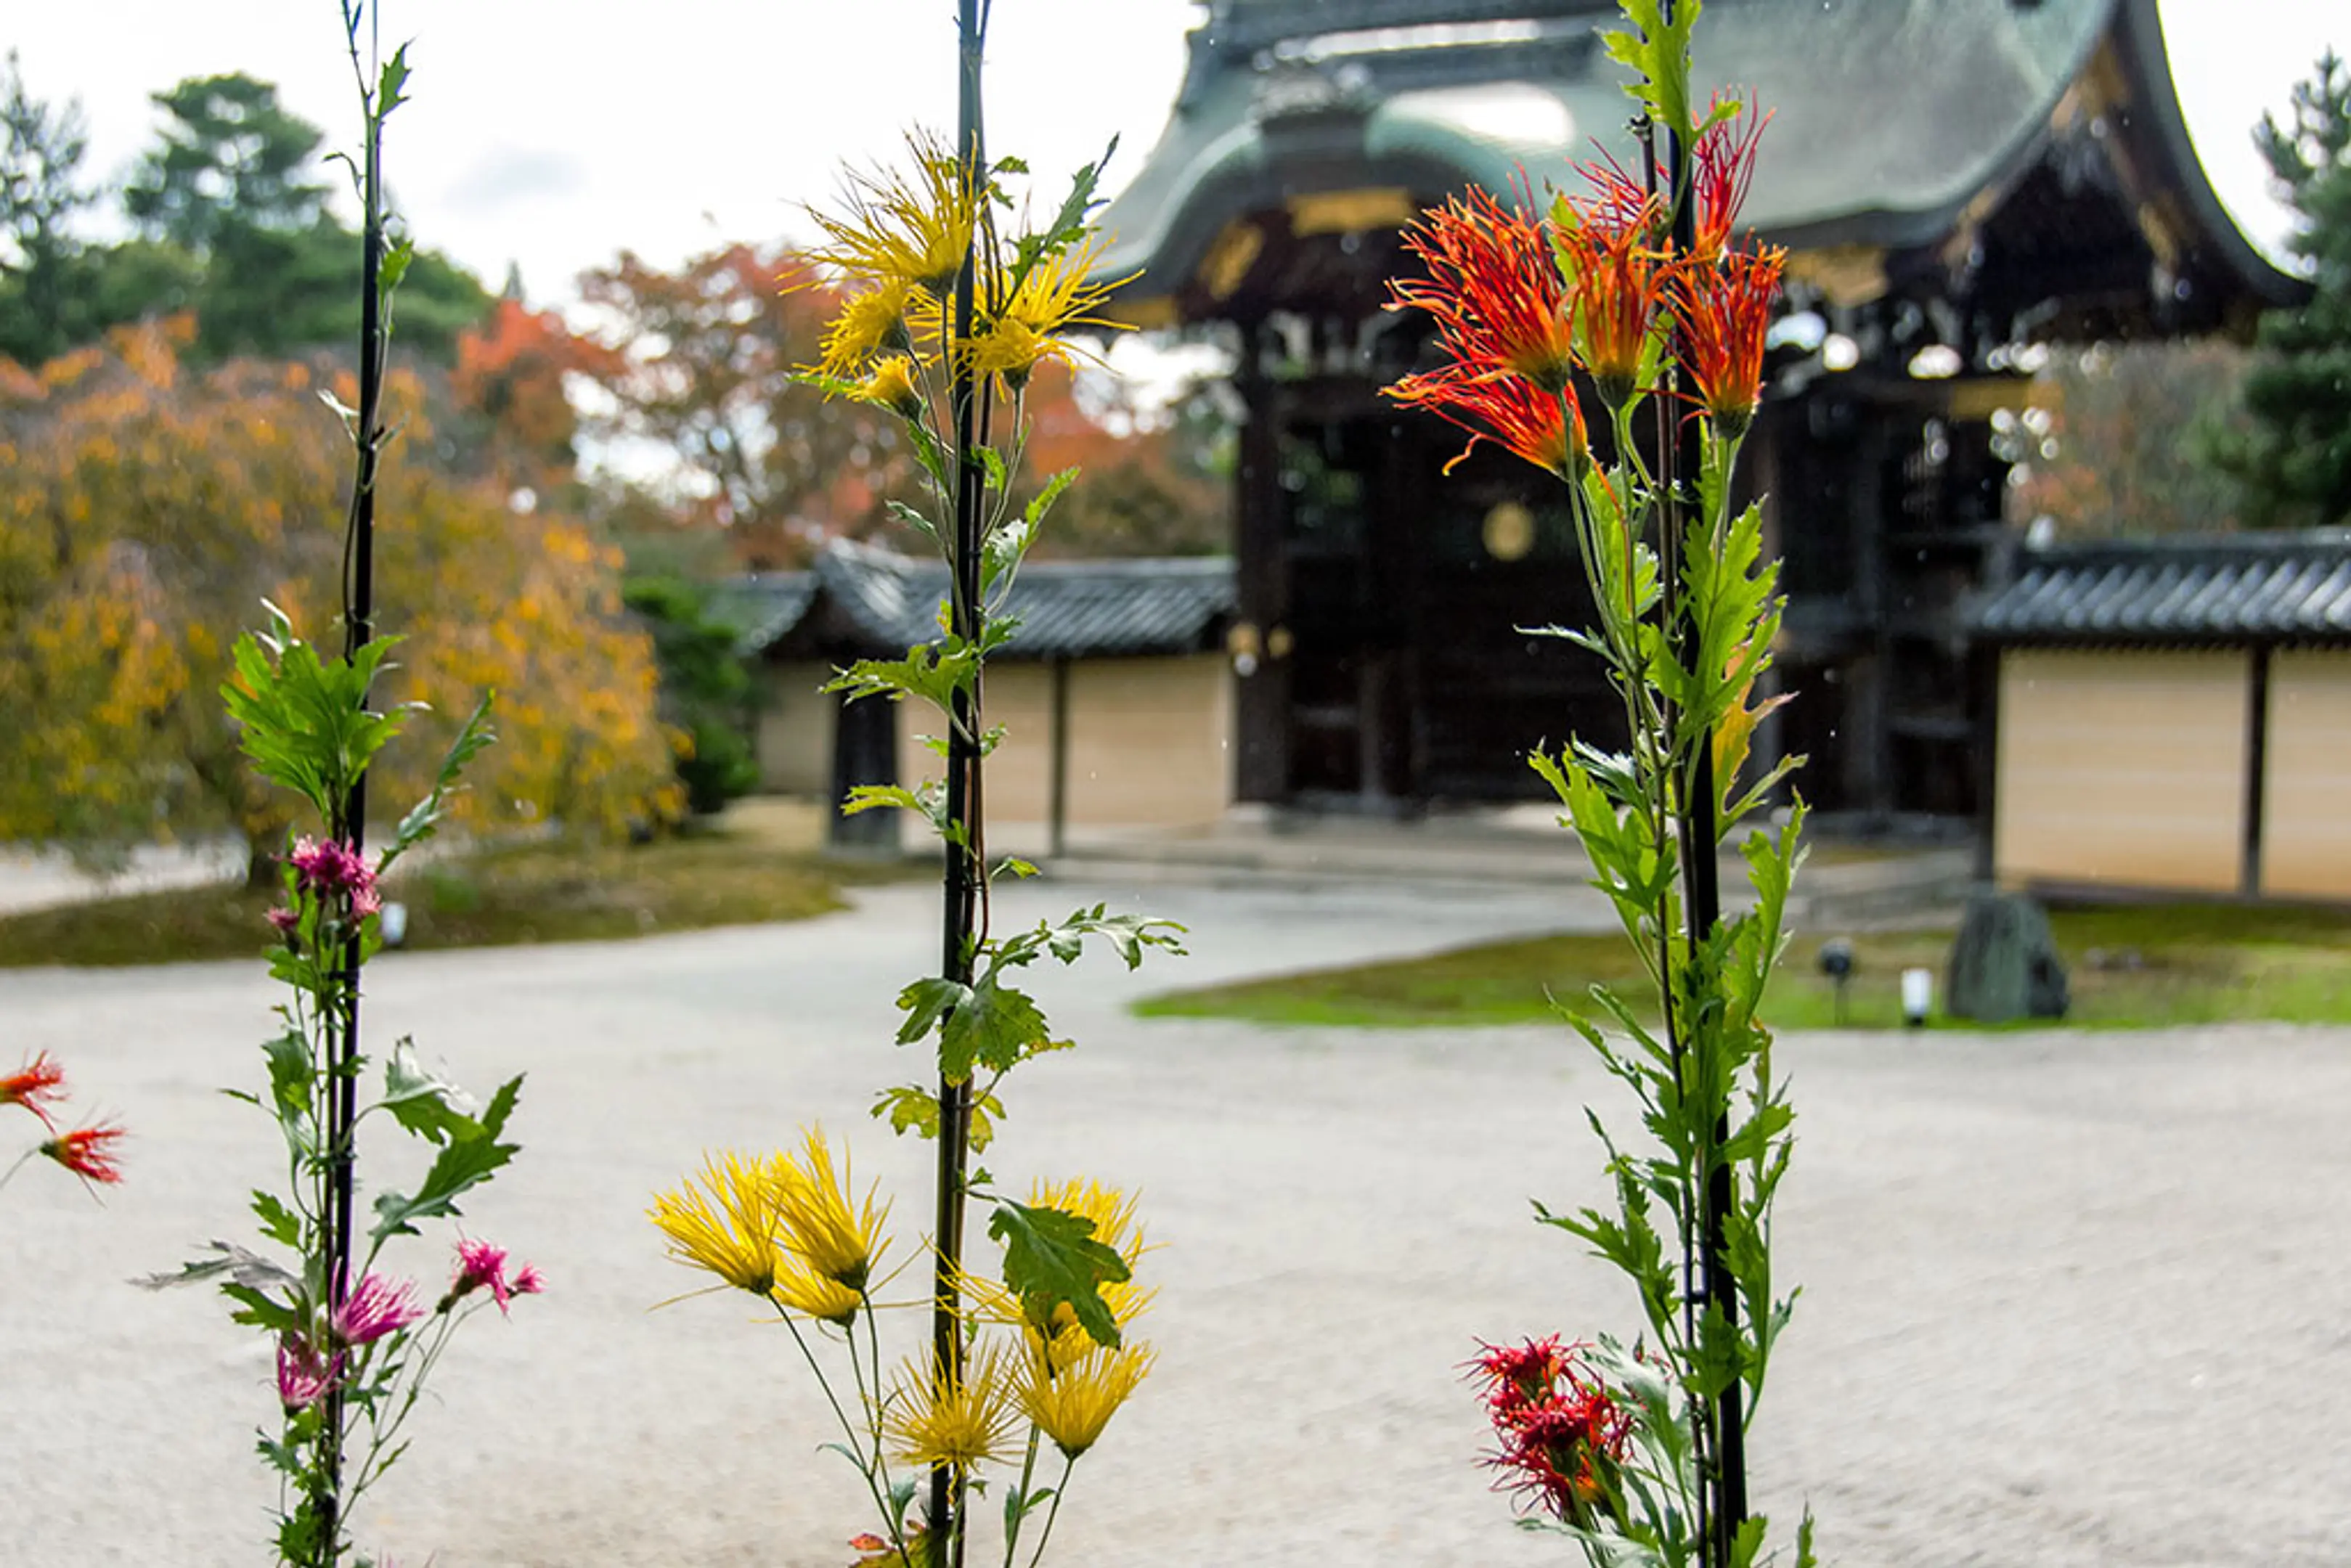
[{"left": 0, "top": 886, "right": 2351, "bottom": 1568}]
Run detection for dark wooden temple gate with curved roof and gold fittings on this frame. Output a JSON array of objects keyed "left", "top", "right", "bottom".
[{"left": 1103, "top": 0, "right": 2299, "bottom": 820}]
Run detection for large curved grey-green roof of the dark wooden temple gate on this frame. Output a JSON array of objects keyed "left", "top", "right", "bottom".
[{"left": 1100, "top": 0, "right": 2294, "bottom": 319}]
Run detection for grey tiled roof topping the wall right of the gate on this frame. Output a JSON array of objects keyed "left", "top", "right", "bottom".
[{"left": 1975, "top": 529, "right": 2351, "bottom": 644}]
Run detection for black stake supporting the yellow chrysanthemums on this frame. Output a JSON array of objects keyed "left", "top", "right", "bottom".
[{"left": 931, "top": 0, "right": 985, "bottom": 1568}]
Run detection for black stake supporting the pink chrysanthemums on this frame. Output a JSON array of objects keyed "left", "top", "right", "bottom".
[{"left": 319, "top": 14, "right": 383, "bottom": 1568}]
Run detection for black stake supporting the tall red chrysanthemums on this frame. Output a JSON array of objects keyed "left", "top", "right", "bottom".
[{"left": 1660, "top": 12, "right": 1747, "bottom": 1564}]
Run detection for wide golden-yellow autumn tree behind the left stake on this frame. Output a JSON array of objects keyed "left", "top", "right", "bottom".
[{"left": 0, "top": 322, "right": 680, "bottom": 872}]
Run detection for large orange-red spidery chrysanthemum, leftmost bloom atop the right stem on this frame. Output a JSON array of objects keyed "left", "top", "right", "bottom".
[{"left": 1387, "top": 188, "right": 1575, "bottom": 393}]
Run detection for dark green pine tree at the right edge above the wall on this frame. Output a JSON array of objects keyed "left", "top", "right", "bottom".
[{"left": 2212, "top": 52, "right": 2351, "bottom": 526}]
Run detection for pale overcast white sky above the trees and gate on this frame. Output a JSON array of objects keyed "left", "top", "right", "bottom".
[{"left": 0, "top": 0, "right": 2351, "bottom": 319}]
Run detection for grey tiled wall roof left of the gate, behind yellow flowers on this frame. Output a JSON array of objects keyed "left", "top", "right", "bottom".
[{"left": 729, "top": 541, "right": 1234, "bottom": 658}]
